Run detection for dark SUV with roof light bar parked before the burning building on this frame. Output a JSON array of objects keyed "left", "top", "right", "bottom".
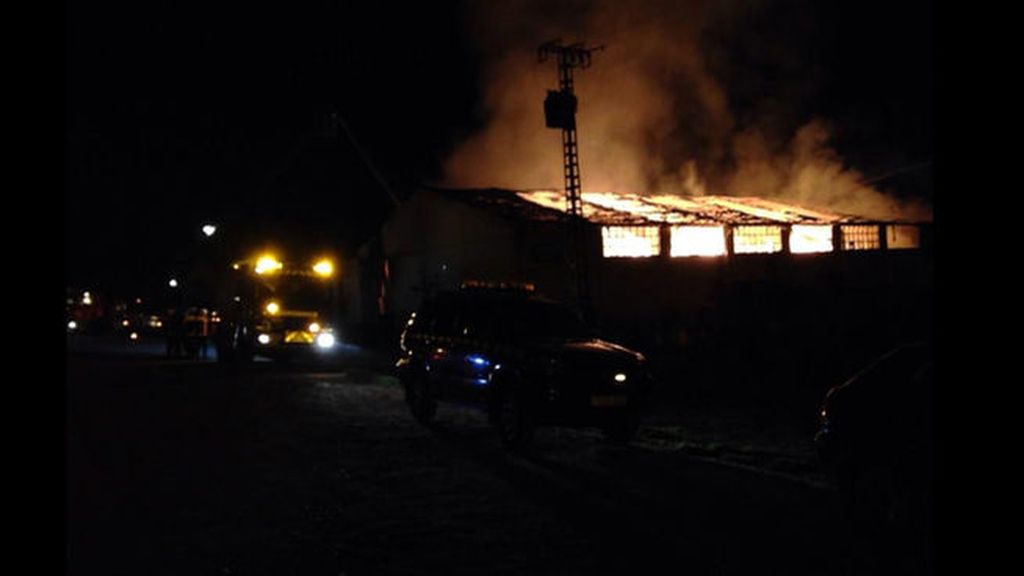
[{"left": 397, "top": 288, "right": 651, "bottom": 448}]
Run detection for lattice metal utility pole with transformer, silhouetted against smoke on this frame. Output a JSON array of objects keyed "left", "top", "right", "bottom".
[{"left": 537, "top": 40, "right": 604, "bottom": 308}]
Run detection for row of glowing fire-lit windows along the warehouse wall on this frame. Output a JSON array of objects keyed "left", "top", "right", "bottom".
[{"left": 601, "top": 224, "right": 921, "bottom": 257}]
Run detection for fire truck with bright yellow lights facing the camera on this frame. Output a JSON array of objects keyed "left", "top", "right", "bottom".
[{"left": 211, "top": 253, "right": 337, "bottom": 362}]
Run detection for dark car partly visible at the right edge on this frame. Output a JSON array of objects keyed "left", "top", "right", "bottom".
[{"left": 815, "top": 342, "right": 935, "bottom": 535}]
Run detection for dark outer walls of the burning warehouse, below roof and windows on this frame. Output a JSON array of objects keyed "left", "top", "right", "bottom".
[{"left": 362, "top": 191, "right": 931, "bottom": 354}]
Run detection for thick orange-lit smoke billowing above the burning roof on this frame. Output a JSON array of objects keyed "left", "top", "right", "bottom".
[{"left": 445, "top": 0, "right": 930, "bottom": 218}]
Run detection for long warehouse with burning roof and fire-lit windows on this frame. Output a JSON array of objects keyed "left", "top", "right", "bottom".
[{"left": 349, "top": 188, "right": 930, "bottom": 352}]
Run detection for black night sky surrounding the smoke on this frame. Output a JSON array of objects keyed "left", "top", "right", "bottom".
[{"left": 65, "top": 0, "right": 934, "bottom": 295}]
